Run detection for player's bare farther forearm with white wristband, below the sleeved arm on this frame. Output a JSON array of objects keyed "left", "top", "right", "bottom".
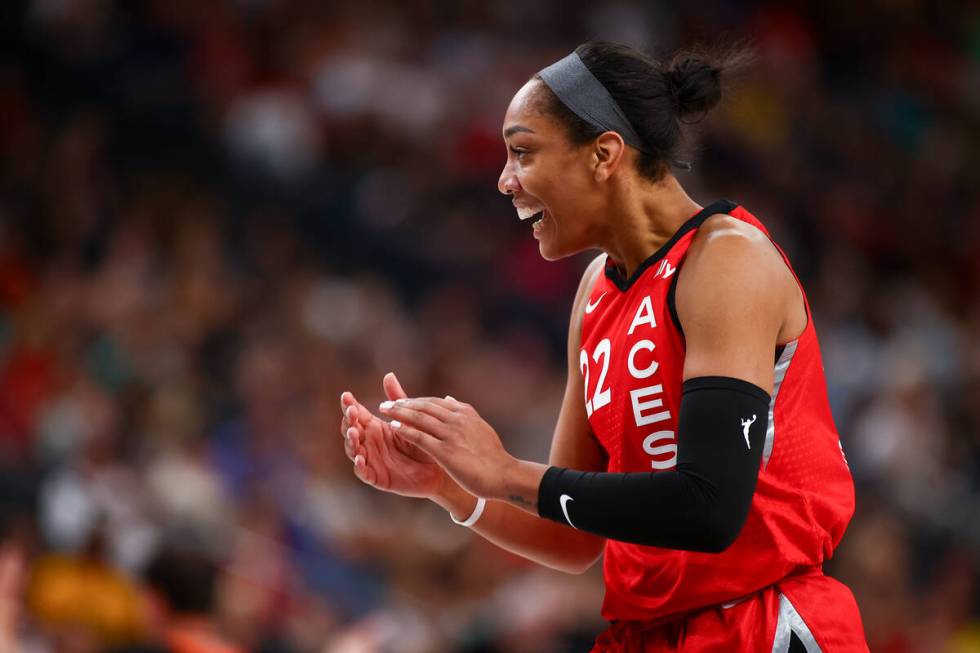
[{"left": 432, "top": 481, "right": 605, "bottom": 574}]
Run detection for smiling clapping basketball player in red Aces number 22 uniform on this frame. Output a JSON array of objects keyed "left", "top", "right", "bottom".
[{"left": 341, "top": 43, "right": 867, "bottom": 653}]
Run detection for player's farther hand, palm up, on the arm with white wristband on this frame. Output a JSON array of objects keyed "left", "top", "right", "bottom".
[{"left": 340, "top": 373, "right": 452, "bottom": 499}]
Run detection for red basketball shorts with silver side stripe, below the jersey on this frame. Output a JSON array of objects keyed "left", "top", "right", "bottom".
[{"left": 592, "top": 569, "right": 868, "bottom": 653}]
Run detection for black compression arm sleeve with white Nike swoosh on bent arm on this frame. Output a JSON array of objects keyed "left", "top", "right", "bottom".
[{"left": 538, "top": 376, "right": 769, "bottom": 553}]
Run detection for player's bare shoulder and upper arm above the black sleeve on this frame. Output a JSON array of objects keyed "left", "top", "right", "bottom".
[{"left": 676, "top": 216, "right": 798, "bottom": 394}]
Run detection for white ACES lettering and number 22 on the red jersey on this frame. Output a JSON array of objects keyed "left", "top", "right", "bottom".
[{"left": 579, "top": 294, "right": 677, "bottom": 470}]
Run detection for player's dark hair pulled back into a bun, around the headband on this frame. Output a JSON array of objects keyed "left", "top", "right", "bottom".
[{"left": 535, "top": 41, "right": 752, "bottom": 180}]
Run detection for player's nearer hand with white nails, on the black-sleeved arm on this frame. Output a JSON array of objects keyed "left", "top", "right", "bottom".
[{"left": 380, "top": 397, "right": 519, "bottom": 499}]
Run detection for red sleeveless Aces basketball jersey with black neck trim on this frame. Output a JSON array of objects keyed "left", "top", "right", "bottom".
[{"left": 579, "top": 201, "right": 854, "bottom": 621}]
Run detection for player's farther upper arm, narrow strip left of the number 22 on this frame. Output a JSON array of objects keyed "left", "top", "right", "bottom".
[{"left": 549, "top": 255, "right": 606, "bottom": 471}]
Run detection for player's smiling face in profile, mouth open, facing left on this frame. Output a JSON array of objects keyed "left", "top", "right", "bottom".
[{"left": 497, "top": 80, "right": 603, "bottom": 261}]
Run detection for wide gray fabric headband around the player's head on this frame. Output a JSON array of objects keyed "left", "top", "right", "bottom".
[{"left": 538, "top": 52, "right": 649, "bottom": 153}]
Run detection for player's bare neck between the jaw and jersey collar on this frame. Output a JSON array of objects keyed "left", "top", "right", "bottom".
[{"left": 600, "top": 175, "right": 701, "bottom": 278}]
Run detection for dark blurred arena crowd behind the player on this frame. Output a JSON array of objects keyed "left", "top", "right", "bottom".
[{"left": 0, "top": 0, "right": 980, "bottom": 653}]
